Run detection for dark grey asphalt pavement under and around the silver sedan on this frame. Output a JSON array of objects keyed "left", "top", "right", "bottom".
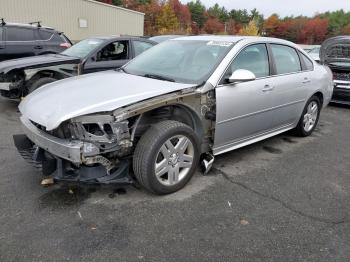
[{"left": 0, "top": 99, "right": 350, "bottom": 262}]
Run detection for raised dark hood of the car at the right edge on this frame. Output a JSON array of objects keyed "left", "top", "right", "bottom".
[{"left": 320, "top": 36, "right": 350, "bottom": 65}]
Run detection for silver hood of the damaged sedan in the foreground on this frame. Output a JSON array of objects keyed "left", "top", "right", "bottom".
[{"left": 19, "top": 71, "right": 193, "bottom": 130}]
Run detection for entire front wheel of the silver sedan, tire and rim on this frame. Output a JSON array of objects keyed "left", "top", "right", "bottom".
[{"left": 133, "top": 120, "right": 200, "bottom": 195}]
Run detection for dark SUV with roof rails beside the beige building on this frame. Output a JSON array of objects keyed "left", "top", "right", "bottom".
[{"left": 0, "top": 20, "right": 72, "bottom": 62}]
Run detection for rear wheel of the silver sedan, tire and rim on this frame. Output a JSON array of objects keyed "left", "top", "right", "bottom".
[{"left": 295, "top": 96, "right": 321, "bottom": 137}]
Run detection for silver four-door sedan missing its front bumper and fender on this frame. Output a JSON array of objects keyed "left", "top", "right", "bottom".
[{"left": 14, "top": 36, "right": 333, "bottom": 194}]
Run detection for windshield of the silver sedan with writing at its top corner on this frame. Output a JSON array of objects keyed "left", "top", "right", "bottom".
[{"left": 123, "top": 40, "right": 233, "bottom": 84}]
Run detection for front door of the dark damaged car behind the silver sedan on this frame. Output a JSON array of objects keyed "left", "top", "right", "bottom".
[{"left": 84, "top": 40, "right": 131, "bottom": 74}]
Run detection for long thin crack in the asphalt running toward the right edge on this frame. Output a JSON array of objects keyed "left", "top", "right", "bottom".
[{"left": 212, "top": 167, "right": 350, "bottom": 225}]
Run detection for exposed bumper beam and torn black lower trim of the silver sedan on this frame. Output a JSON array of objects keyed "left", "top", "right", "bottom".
[{"left": 13, "top": 117, "right": 134, "bottom": 184}]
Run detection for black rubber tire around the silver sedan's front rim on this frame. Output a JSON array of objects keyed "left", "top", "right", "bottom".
[{"left": 133, "top": 120, "right": 200, "bottom": 195}]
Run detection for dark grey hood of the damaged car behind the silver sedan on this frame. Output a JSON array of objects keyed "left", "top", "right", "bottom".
[{"left": 0, "top": 54, "right": 80, "bottom": 74}]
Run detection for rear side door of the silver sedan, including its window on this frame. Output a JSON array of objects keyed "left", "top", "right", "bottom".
[{"left": 269, "top": 44, "right": 311, "bottom": 128}]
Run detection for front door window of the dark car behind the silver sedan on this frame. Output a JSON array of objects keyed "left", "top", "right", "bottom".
[{"left": 96, "top": 41, "right": 129, "bottom": 62}]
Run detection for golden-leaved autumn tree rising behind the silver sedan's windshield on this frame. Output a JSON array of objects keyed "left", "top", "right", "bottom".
[{"left": 156, "top": 4, "right": 179, "bottom": 34}]
